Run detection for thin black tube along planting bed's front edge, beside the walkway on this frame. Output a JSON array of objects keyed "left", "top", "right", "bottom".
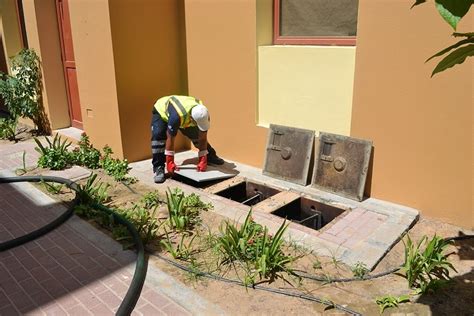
[{"left": 152, "top": 253, "right": 362, "bottom": 316}]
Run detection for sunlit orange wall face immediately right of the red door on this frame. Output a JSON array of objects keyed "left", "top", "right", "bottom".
[{"left": 69, "top": 0, "right": 125, "bottom": 158}]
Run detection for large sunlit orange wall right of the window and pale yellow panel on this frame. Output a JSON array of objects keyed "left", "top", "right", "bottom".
[{"left": 351, "top": 0, "right": 474, "bottom": 228}]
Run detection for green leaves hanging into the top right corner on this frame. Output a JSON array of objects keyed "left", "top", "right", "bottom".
[{"left": 412, "top": 0, "right": 474, "bottom": 76}]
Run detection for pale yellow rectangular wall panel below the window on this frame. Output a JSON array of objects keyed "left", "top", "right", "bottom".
[{"left": 258, "top": 46, "right": 355, "bottom": 135}]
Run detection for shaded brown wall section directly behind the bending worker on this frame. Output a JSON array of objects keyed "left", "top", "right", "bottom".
[{"left": 109, "top": 0, "right": 189, "bottom": 161}]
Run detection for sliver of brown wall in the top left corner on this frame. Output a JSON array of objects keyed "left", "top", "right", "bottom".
[{"left": 0, "top": 0, "right": 23, "bottom": 64}]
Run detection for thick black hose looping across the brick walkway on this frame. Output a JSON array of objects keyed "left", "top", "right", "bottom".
[{"left": 0, "top": 176, "right": 147, "bottom": 316}]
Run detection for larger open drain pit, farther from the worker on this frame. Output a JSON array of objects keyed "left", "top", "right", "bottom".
[{"left": 272, "top": 197, "right": 345, "bottom": 230}]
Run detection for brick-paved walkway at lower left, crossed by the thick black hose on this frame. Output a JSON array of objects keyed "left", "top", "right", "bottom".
[{"left": 0, "top": 142, "right": 224, "bottom": 315}]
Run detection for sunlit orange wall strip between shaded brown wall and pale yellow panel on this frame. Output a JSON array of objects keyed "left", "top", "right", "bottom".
[{"left": 185, "top": 0, "right": 267, "bottom": 167}]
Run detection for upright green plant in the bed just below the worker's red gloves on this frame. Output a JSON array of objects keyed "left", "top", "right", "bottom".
[{"left": 166, "top": 189, "right": 200, "bottom": 231}]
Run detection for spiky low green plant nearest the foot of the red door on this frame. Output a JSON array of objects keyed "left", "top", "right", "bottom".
[{"left": 34, "top": 134, "right": 72, "bottom": 170}]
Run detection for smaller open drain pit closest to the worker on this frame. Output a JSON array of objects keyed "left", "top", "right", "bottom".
[{"left": 215, "top": 181, "right": 280, "bottom": 206}]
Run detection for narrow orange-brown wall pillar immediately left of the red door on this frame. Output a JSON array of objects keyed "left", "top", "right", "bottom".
[{"left": 23, "top": 0, "right": 70, "bottom": 129}]
